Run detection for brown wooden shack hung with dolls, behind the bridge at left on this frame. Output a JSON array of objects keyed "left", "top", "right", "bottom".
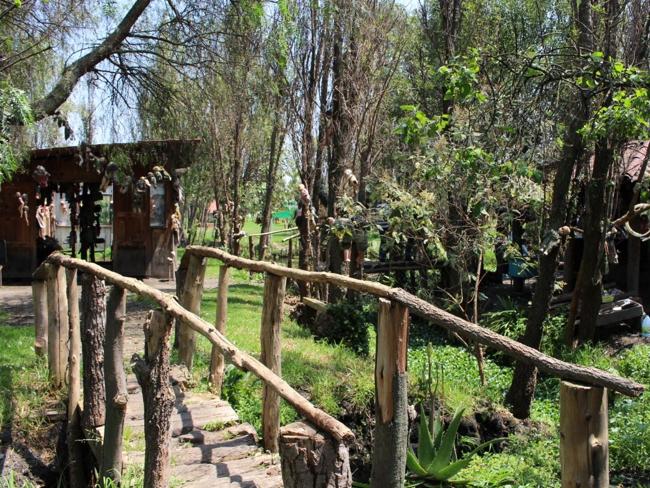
[{"left": 0, "top": 140, "right": 198, "bottom": 280}]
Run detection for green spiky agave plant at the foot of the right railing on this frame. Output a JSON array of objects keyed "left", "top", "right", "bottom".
[{"left": 406, "top": 406, "right": 504, "bottom": 485}]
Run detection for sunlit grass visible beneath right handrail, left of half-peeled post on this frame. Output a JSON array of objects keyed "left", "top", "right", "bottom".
[{"left": 182, "top": 271, "right": 374, "bottom": 430}]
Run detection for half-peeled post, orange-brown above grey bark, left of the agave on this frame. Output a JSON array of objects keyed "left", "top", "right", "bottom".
[{"left": 370, "top": 299, "right": 409, "bottom": 488}]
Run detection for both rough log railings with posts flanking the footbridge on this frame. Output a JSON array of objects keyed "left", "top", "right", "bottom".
[{"left": 34, "top": 246, "right": 643, "bottom": 488}]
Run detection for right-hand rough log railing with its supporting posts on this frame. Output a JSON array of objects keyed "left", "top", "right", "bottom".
[{"left": 181, "top": 246, "right": 644, "bottom": 488}]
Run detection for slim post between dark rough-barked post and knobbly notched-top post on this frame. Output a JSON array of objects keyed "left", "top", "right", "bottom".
[{"left": 100, "top": 286, "right": 128, "bottom": 485}]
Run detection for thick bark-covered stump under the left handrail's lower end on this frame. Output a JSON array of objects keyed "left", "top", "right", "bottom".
[{"left": 280, "top": 422, "right": 352, "bottom": 488}]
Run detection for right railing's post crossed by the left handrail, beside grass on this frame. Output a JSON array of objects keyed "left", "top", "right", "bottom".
[{"left": 260, "top": 273, "right": 287, "bottom": 452}]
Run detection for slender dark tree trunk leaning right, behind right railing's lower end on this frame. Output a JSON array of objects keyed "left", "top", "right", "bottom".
[{"left": 506, "top": 0, "right": 593, "bottom": 418}]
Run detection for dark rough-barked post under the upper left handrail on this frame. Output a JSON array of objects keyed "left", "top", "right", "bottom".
[{"left": 80, "top": 273, "right": 106, "bottom": 429}]
